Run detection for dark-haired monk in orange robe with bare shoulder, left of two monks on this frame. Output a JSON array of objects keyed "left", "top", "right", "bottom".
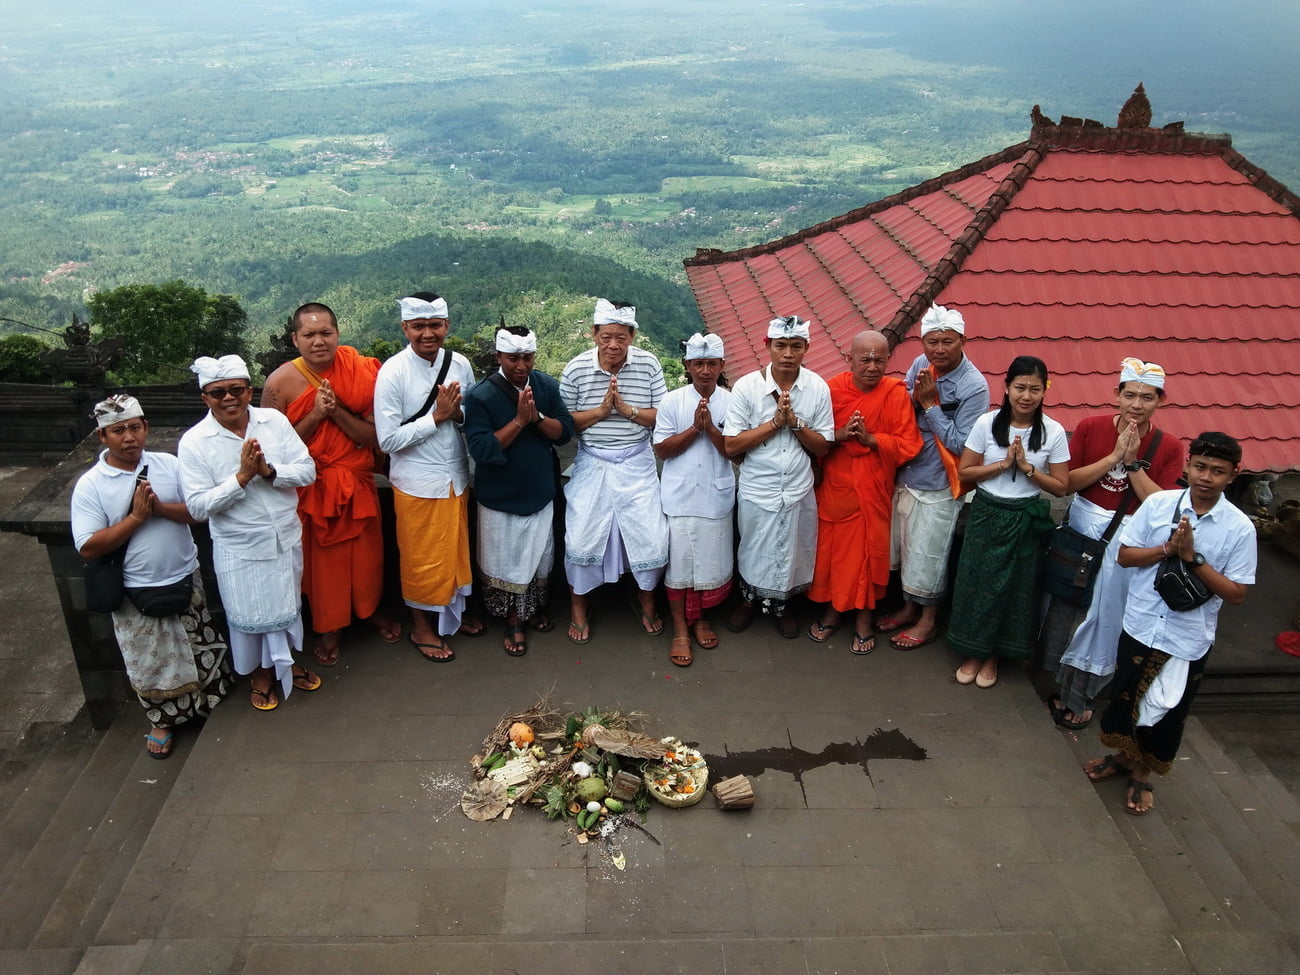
[{"left": 261, "top": 302, "right": 402, "bottom": 667}]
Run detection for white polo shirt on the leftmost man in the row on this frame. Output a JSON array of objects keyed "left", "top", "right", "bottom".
[{"left": 72, "top": 450, "right": 199, "bottom": 589}]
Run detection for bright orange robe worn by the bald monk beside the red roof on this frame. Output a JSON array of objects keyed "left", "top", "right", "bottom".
[{"left": 809, "top": 372, "right": 922, "bottom": 612}]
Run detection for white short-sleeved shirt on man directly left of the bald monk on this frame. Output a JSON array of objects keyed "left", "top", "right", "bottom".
[{"left": 725, "top": 365, "right": 835, "bottom": 511}]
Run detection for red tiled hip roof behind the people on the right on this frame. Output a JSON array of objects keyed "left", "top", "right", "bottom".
[{"left": 685, "top": 106, "right": 1300, "bottom": 471}]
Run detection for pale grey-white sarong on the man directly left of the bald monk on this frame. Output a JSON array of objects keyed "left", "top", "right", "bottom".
[{"left": 737, "top": 491, "right": 816, "bottom": 602}]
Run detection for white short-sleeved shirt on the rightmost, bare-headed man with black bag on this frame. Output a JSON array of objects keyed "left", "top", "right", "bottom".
[{"left": 1119, "top": 489, "right": 1258, "bottom": 660}]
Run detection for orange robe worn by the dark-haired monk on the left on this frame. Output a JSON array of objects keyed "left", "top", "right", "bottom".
[{"left": 285, "top": 346, "right": 384, "bottom": 633}]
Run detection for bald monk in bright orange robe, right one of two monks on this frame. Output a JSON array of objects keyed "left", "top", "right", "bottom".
[{"left": 809, "top": 332, "right": 922, "bottom": 654}]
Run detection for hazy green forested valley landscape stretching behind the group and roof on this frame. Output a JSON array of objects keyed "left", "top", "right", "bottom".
[{"left": 0, "top": 0, "right": 1300, "bottom": 377}]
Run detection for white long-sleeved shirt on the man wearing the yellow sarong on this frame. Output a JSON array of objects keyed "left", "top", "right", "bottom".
[{"left": 374, "top": 346, "right": 475, "bottom": 498}]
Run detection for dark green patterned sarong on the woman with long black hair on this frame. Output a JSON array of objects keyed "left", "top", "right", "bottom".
[{"left": 948, "top": 488, "right": 1052, "bottom": 660}]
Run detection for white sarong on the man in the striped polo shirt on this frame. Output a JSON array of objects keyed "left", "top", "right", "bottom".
[{"left": 564, "top": 441, "right": 668, "bottom": 581}]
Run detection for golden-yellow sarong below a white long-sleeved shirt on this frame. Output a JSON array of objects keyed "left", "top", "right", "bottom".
[{"left": 393, "top": 488, "right": 472, "bottom": 606}]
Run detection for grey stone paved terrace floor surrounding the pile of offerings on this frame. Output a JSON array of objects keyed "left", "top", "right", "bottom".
[{"left": 0, "top": 467, "right": 1300, "bottom": 975}]
